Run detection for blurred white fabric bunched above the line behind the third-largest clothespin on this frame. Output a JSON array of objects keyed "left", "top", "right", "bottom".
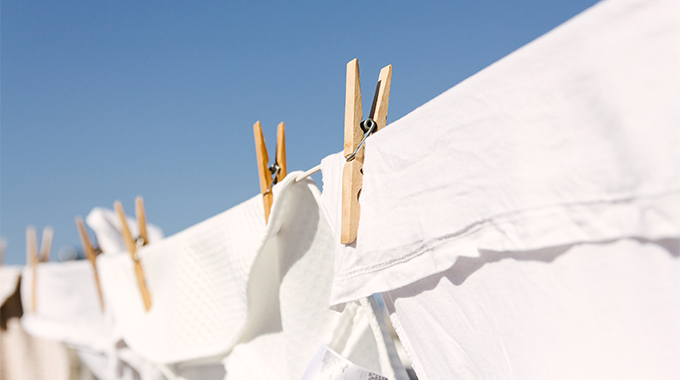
[{"left": 85, "top": 207, "right": 163, "bottom": 253}]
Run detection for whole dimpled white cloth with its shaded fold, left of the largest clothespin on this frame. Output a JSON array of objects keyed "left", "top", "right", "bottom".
[{"left": 97, "top": 173, "right": 402, "bottom": 379}]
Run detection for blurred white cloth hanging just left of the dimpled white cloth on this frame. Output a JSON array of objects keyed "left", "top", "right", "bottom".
[{"left": 21, "top": 260, "right": 165, "bottom": 380}]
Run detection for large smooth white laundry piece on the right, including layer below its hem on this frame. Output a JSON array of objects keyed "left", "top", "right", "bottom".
[{"left": 322, "top": 0, "right": 680, "bottom": 379}]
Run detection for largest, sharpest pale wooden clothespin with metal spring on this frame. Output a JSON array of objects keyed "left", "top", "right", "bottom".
[{"left": 340, "top": 59, "right": 392, "bottom": 244}]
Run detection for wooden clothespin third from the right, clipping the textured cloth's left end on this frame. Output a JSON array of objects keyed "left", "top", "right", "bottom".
[{"left": 113, "top": 197, "right": 151, "bottom": 311}]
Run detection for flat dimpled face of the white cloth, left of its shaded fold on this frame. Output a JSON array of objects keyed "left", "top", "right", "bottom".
[{"left": 97, "top": 180, "right": 265, "bottom": 363}]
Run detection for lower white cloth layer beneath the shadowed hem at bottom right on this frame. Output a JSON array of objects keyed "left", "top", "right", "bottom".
[{"left": 385, "top": 239, "right": 680, "bottom": 380}]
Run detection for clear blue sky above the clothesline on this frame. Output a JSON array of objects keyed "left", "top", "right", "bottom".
[{"left": 0, "top": 0, "right": 594, "bottom": 264}]
